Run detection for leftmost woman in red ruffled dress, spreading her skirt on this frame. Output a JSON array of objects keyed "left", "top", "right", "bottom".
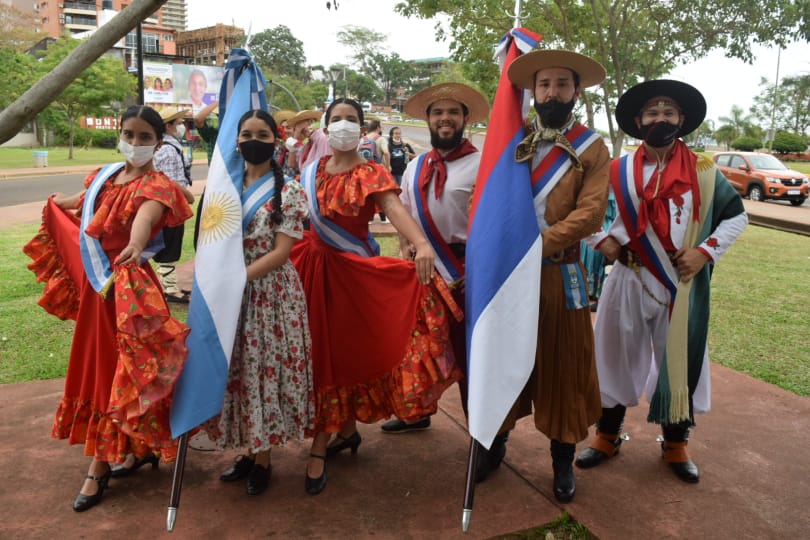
[{"left": 24, "top": 106, "right": 192, "bottom": 512}]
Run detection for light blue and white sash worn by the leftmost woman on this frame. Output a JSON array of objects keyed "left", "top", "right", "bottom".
[{"left": 79, "top": 162, "right": 164, "bottom": 294}]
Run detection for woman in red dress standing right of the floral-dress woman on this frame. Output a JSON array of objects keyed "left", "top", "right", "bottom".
[{"left": 291, "top": 98, "right": 461, "bottom": 495}]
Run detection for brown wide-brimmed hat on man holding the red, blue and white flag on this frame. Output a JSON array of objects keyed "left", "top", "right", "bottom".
[{"left": 507, "top": 49, "right": 607, "bottom": 90}]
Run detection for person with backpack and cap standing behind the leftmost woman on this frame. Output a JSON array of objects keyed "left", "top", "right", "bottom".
[{"left": 154, "top": 107, "right": 194, "bottom": 304}]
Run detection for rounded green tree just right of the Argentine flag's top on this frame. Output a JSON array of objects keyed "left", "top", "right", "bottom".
[{"left": 248, "top": 25, "right": 307, "bottom": 80}]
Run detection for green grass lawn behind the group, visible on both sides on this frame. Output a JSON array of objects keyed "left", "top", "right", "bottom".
[{"left": 0, "top": 220, "right": 810, "bottom": 396}]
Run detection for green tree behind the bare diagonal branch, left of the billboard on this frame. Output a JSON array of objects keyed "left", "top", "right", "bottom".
[{"left": 39, "top": 38, "right": 136, "bottom": 159}]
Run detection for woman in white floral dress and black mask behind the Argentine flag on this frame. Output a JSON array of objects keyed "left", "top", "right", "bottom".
[{"left": 204, "top": 110, "right": 315, "bottom": 496}]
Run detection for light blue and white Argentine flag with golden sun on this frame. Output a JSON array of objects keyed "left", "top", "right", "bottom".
[{"left": 171, "top": 49, "right": 267, "bottom": 437}]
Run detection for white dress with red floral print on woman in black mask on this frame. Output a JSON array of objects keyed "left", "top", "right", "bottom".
[{"left": 204, "top": 181, "right": 315, "bottom": 453}]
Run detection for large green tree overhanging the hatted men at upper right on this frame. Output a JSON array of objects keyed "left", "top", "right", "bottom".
[{"left": 395, "top": 0, "right": 810, "bottom": 156}]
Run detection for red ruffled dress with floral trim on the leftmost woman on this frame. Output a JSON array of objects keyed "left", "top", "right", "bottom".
[{"left": 23, "top": 169, "right": 192, "bottom": 462}]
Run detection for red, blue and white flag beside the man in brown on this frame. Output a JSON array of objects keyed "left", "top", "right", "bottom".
[{"left": 465, "top": 28, "right": 543, "bottom": 448}]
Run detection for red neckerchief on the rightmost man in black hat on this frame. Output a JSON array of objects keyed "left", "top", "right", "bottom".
[{"left": 633, "top": 140, "right": 700, "bottom": 251}]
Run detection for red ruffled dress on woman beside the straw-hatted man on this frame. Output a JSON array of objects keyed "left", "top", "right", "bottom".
[{"left": 290, "top": 157, "right": 461, "bottom": 433}]
